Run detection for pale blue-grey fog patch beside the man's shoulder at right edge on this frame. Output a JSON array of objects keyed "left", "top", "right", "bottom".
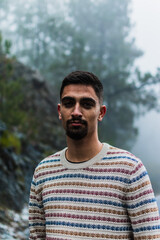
[{"left": 132, "top": 111, "right": 160, "bottom": 194}]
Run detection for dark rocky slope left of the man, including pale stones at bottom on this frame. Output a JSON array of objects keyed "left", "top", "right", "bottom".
[{"left": 0, "top": 58, "right": 65, "bottom": 236}]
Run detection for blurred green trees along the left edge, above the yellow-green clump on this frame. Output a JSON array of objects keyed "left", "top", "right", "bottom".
[{"left": 0, "top": 34, "right": 26, "bottom": 128}]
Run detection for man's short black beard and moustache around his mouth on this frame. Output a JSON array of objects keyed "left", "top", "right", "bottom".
[{"left": 66, "top": 118, "right": 88, "bottom": 140}]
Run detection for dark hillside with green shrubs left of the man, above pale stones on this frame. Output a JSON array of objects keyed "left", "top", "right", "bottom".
[{"left": 0, "top": 59, "right": 65, "bottom": 239}]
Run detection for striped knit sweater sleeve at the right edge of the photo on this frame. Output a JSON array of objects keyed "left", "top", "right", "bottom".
[{"left": 126, "top": 161, "right": 160, "bottom": 240}]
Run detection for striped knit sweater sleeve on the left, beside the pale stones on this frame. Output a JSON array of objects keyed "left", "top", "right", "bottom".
[{"left": 29, "top": 174, "right": 46, "bottom": 240}]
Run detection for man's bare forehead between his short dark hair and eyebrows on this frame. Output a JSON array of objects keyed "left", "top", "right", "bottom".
[{"left": 61, "top": 84, "right": 98, "bottom": 102}]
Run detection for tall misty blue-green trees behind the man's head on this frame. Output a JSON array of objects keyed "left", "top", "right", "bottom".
[{"left": 0, "top": 0, "right": 159, "bottom": 147}]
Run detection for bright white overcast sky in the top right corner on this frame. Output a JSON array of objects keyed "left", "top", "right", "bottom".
[{"left": 131, "top": 0, "right": 160, "bottom": 73}]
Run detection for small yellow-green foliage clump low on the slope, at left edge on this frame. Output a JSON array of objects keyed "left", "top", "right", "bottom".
[{"left": 0, "top": 130, "right": 21, "bottom": 154}]
